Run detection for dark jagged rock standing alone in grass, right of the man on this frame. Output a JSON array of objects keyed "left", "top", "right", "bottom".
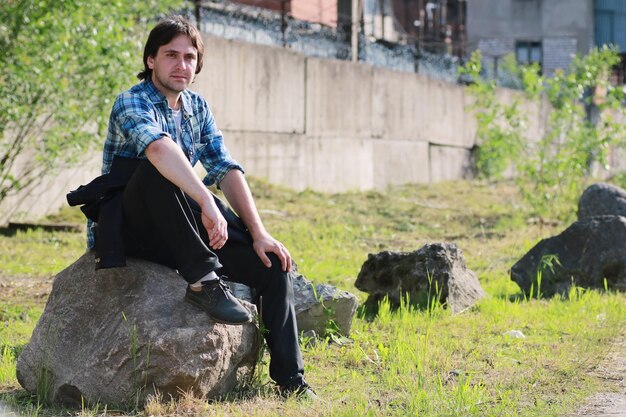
[{"left": 355, "top": 243, "right": 485, "bottom": 313}]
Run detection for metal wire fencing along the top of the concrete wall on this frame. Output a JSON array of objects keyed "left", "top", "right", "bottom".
[{"left": 195, "top": 0, "right": 460, "bottom": 82}]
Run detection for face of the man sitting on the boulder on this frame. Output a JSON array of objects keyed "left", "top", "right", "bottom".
[{"left": 148, "top": 35, "right": 198, "bottom": 96}]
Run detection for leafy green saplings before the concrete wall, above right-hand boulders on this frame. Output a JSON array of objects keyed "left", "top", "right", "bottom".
[{"left": 461, "top": 47, "right": 625, "bottom": 218}]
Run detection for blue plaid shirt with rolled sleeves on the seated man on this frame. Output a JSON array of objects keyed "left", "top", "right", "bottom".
[{"left": 87, "top": 80, "right": 243, "bottom": 249}]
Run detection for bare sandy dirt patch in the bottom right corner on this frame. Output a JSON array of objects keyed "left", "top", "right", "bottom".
[{"left": 569, "top": 329, "right": 626, "bottom": 417}]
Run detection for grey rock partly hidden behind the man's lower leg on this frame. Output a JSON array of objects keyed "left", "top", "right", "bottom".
[{"left": 228, "top": 263, "right": 358, "bottom": 336}]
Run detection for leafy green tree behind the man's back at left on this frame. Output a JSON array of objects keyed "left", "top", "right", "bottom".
[{"left": 0, "top": 0, "right": 183, "bottom": 201}]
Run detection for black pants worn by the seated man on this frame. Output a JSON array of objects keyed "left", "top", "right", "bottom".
[{"left": 123, "top": 160, "right": 304, "bottom": 385}]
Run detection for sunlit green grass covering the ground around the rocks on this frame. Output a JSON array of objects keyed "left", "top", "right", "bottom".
[{"left": 0, "top": 180, "right": 626, "bottom": 416}]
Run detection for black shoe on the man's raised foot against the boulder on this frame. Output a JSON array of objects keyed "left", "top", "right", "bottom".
[{"left": 185, "top": 279, "right": 252, "bottom": 324}]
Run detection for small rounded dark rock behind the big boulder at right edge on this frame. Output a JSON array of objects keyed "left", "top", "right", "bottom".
[{"left": 578, "top": 183, "right": 626, "bottom": 220}]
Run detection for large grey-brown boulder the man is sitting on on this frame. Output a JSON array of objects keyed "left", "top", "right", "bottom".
[{"left": 17, "top": 253, "right": 260, "bottom": 405}]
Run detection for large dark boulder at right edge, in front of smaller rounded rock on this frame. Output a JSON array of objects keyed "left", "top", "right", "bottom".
[{"left": 511, "top": 216, "right": 626, "bottom": 296}]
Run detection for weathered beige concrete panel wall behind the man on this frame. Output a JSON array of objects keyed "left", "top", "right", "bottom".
[{"left": 0, "top": 36, "right": 542, "bottom": 223}]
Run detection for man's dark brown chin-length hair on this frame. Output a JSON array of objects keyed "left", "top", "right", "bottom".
[{"left": 137, "top": 16, "right": 204, "bottom": 80}]
